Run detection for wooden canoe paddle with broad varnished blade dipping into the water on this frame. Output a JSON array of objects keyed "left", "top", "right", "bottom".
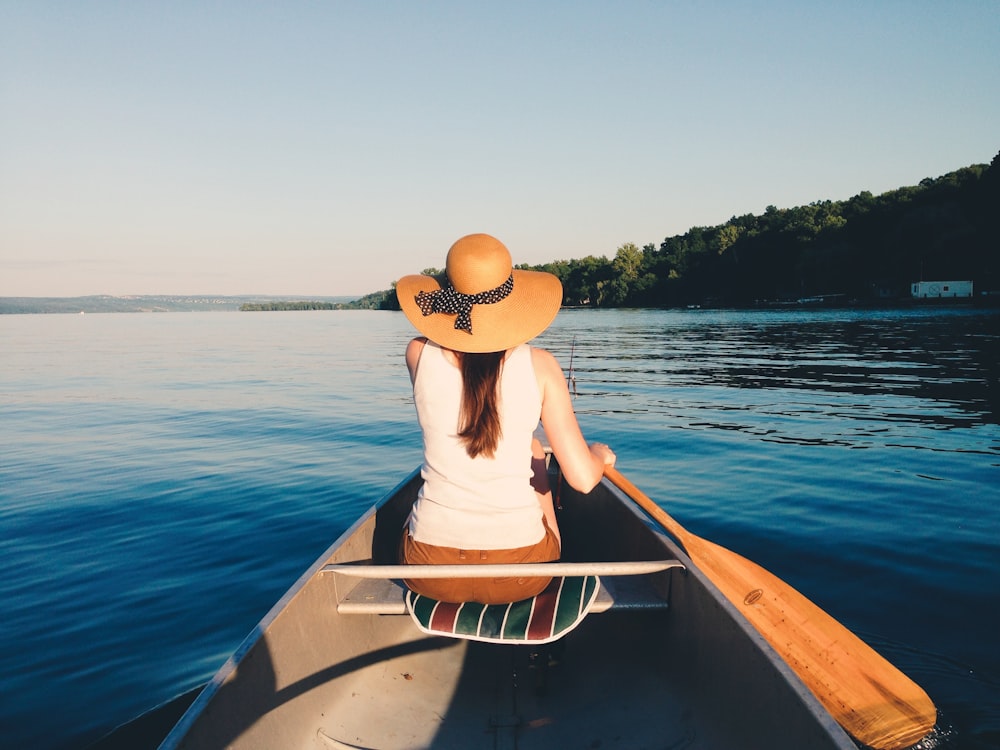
[{"left": 604, "top": 467, "right": 937, "bottom": 750}]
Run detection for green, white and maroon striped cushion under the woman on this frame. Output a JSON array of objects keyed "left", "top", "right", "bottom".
[{"left": 406, "top": 576, "right": 601, "bottom": 643}]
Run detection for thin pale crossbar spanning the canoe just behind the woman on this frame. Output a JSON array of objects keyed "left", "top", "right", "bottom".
[{"left": 320, "top": 560, "right": 684, "bottom": 578}]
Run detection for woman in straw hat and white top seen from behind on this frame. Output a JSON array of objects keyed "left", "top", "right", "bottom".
[{"left": 396, "top": 234, "right": 615, "bottom": 604}]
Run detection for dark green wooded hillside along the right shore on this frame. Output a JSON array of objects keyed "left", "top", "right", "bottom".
[{"left": 370, "top": 154, "right": 1000, "bottom": 309}]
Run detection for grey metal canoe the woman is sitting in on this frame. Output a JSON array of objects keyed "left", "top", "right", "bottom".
[{"left": 160, "top": 466, "right": 857, "bottom": 750}]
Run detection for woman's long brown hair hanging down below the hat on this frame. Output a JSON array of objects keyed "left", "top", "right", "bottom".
[{"left": 455, "top": 352, "right": 506, "bottom": 458}]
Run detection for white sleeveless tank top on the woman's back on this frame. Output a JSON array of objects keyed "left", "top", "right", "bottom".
[{"left": 409, "top": 341, "right": 545, "bottom": 550}]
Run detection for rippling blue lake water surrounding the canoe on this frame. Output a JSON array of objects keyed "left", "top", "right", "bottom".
[{"left": 0, "top": 309, "right": 1000, "bottom": 750}]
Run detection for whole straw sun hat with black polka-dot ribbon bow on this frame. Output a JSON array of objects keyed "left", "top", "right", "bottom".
[{"left": 396, "top": 234, "right": 562, "bottom": 352}]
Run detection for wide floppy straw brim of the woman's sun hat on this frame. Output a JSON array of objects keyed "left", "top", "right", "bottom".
[{"left": 396, "top": 270, "right": 562, "bottom": 353}]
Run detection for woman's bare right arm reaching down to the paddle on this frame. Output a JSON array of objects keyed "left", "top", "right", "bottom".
[{"left": 531, "top": 347, "right": 615, "bottom": 492}]
